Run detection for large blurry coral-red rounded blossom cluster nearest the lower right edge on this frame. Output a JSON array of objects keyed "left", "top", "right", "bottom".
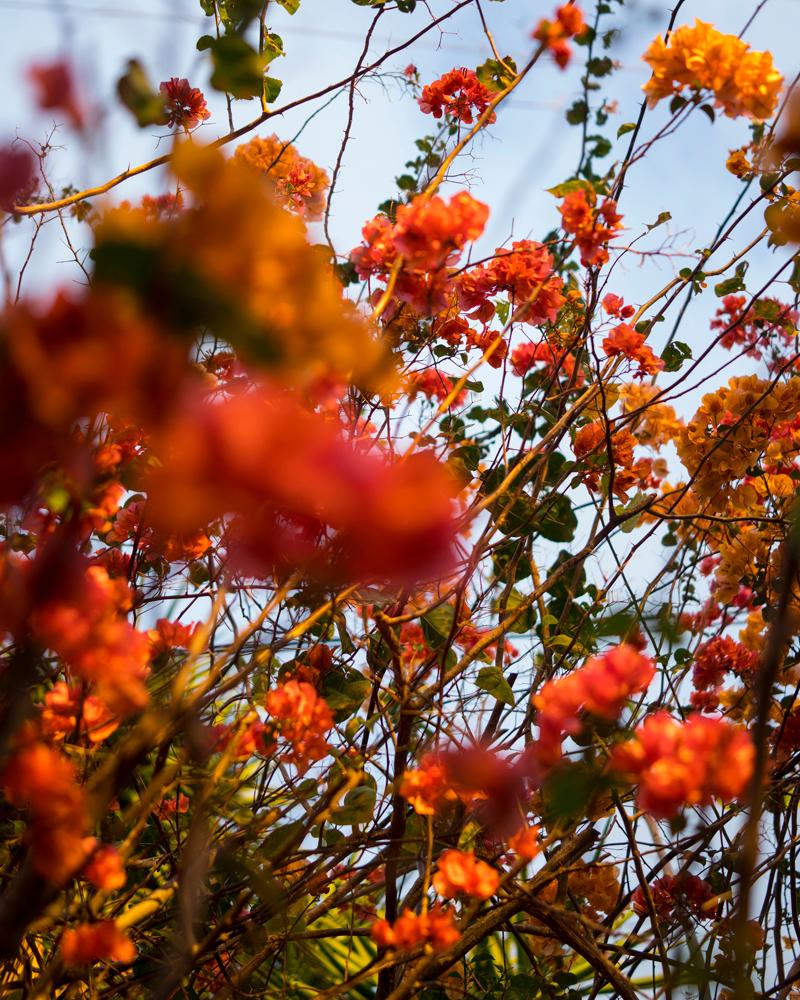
[{"left": 611, "top": 711, "right": 755, "bottom": 819}]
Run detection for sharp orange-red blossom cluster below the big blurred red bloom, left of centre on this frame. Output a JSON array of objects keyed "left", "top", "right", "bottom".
[{"left": 264, "top": 680, "right": 333, "bottom": 774}]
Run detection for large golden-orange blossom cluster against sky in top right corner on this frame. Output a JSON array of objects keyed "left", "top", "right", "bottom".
[{"left": 642, "top": 20, "right": 783, "bottom": 121}]
